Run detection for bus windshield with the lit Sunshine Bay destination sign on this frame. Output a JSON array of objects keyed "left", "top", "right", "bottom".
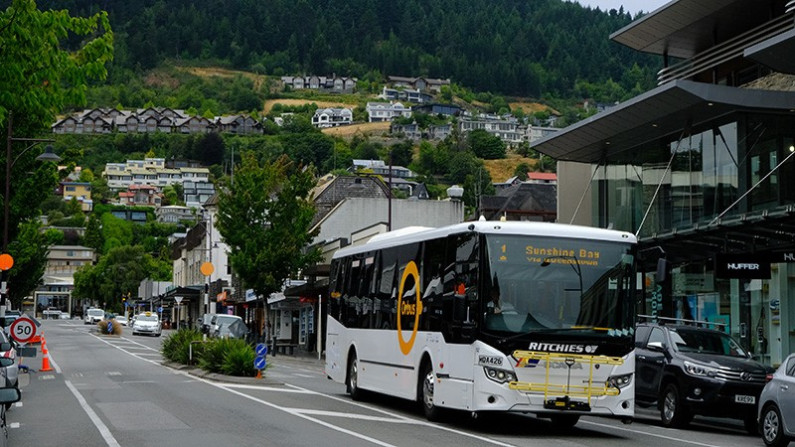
[{"left": 483, "top": 235, "right": 634, "bottom": 336}]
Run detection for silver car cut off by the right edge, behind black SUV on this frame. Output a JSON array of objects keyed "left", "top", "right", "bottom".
[{"left": 759, "top": 354, "right": 795, "bottom": 447}]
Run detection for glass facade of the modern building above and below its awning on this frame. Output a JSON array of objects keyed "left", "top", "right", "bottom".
[{"left": 590, "top": 111, "right": 795, "bottom": 364}]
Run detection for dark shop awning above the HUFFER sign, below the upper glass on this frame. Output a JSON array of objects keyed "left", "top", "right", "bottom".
[{"left": 639, "top": 205, "right": 795, "bottom": 264}]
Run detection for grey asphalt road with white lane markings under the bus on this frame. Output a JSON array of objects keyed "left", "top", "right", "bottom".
[{"left": 8, "top": 320, "right": 763, "bottom": 447}]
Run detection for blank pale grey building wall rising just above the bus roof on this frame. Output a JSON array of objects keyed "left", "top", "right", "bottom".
[{"left": 314, "top": 198, "right": 464, "bottom": 243}]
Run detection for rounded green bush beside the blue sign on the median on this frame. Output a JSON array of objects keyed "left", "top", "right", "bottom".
[{"left": 199, "top": 338, "right": 257, "bottom": 376}]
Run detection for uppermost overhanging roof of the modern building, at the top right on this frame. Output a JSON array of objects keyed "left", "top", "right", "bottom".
[{"left": 610, "top": 0, "right": 786, "bottom": 59}]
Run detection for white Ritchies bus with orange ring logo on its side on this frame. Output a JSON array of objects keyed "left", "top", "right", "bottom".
[{"left": 326, "top": 221, "right": 637, "bottom": 426}]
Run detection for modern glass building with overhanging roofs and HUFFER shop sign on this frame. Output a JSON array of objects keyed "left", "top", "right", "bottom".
[{"left": 534, "top": 0, "right": 795, "bottom": 365}]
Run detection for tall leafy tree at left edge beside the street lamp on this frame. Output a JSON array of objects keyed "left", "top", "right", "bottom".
[{"left": 0, "top": 0, "right": 113, "bottom": 304}]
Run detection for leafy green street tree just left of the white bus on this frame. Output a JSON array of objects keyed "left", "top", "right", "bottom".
[{"left": 217, "top": 152, "right": 320, "bottom": 302}]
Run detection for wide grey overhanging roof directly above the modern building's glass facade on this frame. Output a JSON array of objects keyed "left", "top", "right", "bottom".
[{"left": 533, "top": 80, "right": 795, "bottom": 163}]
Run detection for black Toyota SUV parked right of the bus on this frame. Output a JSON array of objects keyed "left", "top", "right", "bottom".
[{"left": 635, "top": 323, "right": 773, "bottom": 434}]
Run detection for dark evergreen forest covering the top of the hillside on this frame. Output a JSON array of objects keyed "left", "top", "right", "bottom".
[{"left": 38, "top": 0, "right": 661, "bottom": 98}]
